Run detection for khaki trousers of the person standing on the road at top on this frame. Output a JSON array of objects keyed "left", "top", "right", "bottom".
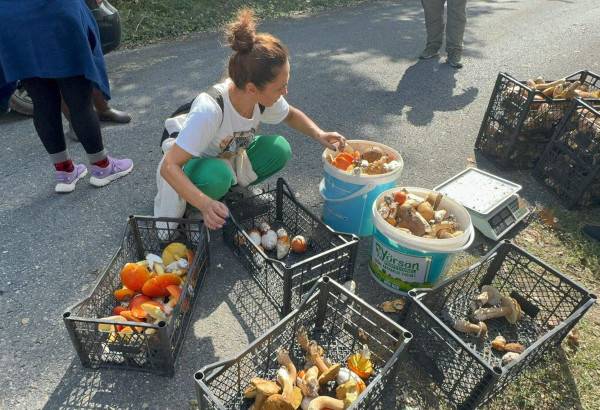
[{"left": 421, "top": 0, "right": 467, "bottom": 53}]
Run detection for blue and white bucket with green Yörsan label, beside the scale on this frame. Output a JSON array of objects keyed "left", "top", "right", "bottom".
[{"left": 369, "top": 188, "right": 475, "bottom": 294}]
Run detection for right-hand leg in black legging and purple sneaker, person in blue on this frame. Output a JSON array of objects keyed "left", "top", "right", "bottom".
[{"left": 57, "top": 76, "right": 133, "bottom": 187}]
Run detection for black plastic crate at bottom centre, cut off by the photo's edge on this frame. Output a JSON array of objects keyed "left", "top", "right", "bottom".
[{"left": 195, "top": 277, "right": 412, "bottom": 410}]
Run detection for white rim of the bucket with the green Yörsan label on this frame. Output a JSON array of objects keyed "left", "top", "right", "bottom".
[{"left": 372, "top": 186, "right": 475, "bottom": 253}]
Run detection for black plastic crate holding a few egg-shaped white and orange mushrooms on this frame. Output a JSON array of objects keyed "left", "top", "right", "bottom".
[{"left": 223, "top": 178, "right": 358, "bottom": 317}]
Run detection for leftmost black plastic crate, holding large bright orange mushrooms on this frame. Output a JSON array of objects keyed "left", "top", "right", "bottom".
[{"left": 63, "top": 216, "right": 209, "bottom": 376}]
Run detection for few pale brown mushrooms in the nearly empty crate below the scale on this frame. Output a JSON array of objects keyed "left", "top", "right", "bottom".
[{"left": 453, "top": 285, "right": 525, "bottom": 366}]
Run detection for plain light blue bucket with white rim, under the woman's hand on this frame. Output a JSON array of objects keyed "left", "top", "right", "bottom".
[{"left": 319, "top": 140, "right": 404, "bottom": 236}]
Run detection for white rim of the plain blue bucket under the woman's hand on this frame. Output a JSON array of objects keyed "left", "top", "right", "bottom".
[{"left": 321, "top": 140, "right": 404, "bottom": 185}]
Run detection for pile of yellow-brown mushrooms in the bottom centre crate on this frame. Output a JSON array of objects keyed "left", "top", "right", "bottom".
[{"left": 244, "top": 328, "right": 373, "bottom": 410}]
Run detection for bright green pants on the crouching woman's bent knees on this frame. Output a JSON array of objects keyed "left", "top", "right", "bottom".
[{"left": 183, "top": 135, "right": 292, "bottom": 199}]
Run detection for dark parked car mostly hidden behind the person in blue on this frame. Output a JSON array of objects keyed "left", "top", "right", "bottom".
[{"left": 9, "top": 0, "right": 121, "bottom": 116}]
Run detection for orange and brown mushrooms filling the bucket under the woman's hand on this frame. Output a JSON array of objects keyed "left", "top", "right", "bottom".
[{"left": 323, "top": 140, "right": 403, "bottom": 176}]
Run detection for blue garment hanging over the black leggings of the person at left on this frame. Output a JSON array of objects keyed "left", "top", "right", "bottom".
[{"left": 0, "top": 0, "right": 110, "bottom": 98}]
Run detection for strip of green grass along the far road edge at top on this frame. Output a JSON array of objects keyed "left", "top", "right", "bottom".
[{"left": 111, "top": 0, "right": 366, "bottom": 48}]
